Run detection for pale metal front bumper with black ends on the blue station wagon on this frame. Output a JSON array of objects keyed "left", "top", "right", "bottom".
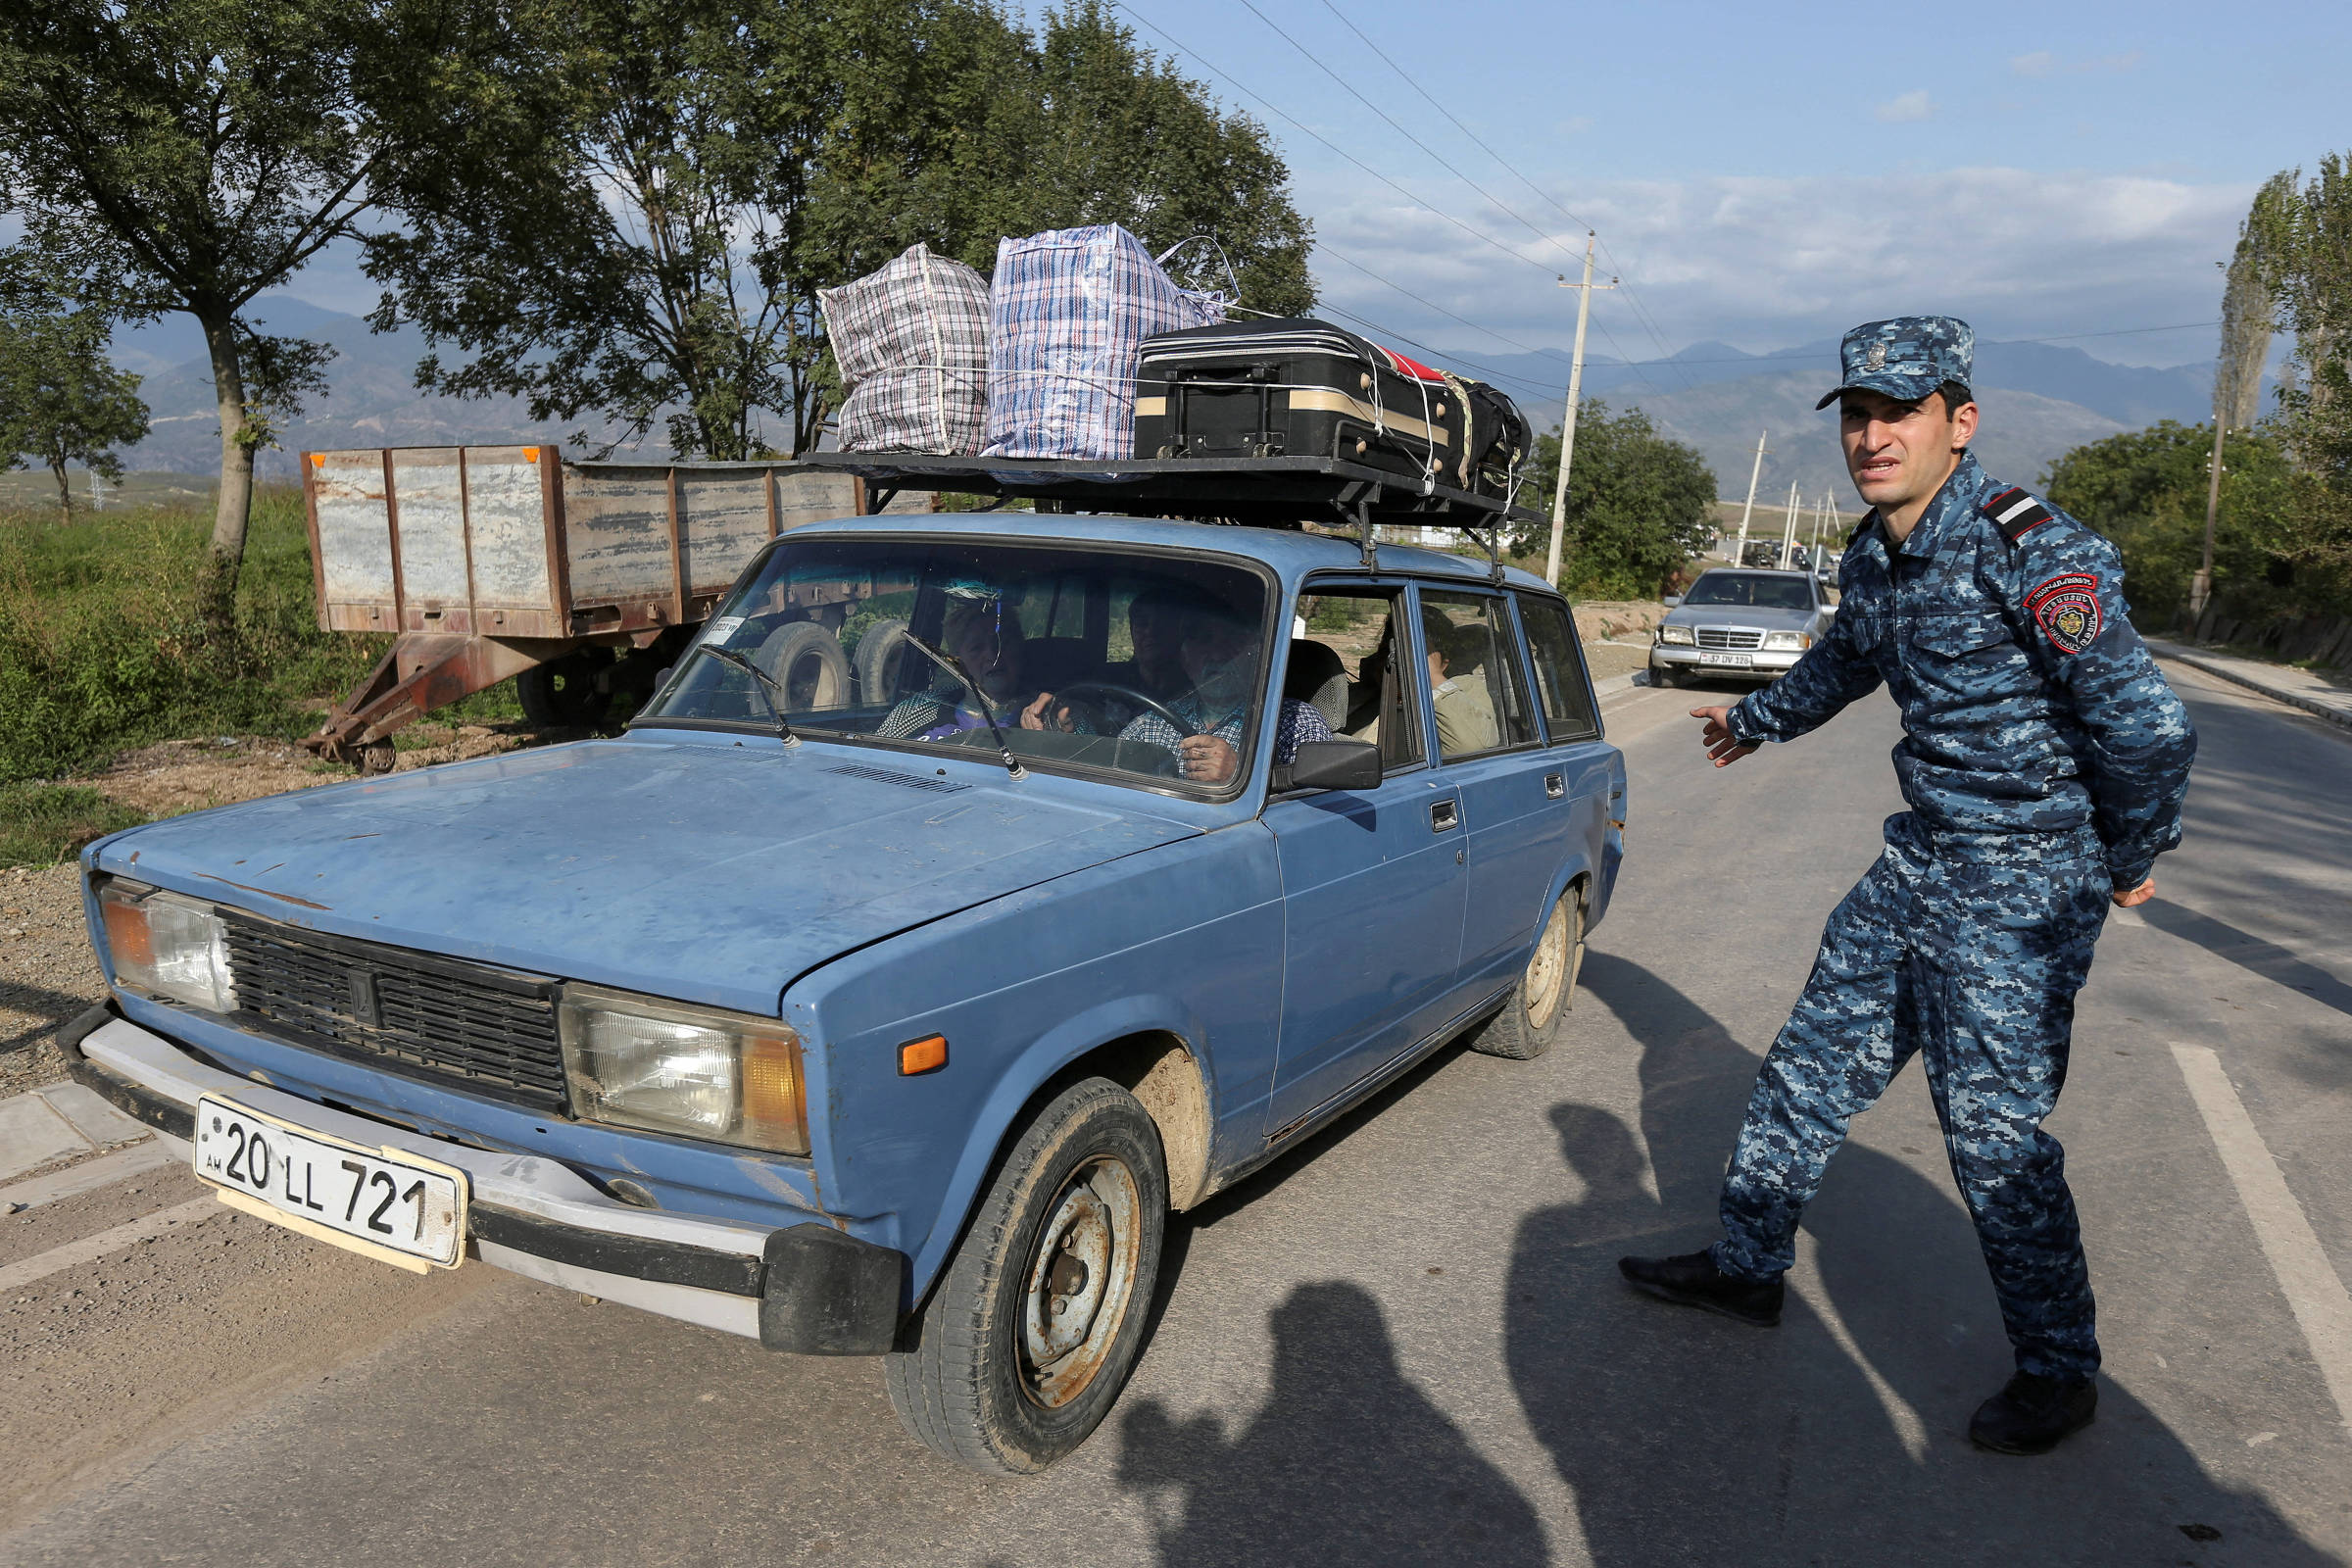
[{"left": 59, "top": 1008, "right": 907, "bottom": 1356}]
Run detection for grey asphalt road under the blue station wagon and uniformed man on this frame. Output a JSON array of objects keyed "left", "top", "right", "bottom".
[{"left": 0, "top": 667, "right": 2352, "bottom": 1568}]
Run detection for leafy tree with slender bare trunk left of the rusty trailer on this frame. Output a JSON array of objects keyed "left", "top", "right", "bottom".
[{"left": 0, "top": 0, "right": 486, "bottom": 632}]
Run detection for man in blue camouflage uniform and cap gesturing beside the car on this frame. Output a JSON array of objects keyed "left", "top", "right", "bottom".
[{"left": 1618, "top": 315, "right": 2197, "bottom": 1452}]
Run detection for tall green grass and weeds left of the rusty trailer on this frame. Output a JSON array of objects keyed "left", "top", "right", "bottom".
[{"left": 0, "top": 487, "right": 390, "bottom": 785}]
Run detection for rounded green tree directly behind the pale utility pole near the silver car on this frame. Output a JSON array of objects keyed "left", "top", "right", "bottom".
[{"left": 1512, "top": 397, "right": 1715, "bottom": 600}]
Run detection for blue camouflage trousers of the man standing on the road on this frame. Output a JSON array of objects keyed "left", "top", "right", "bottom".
[{"left": 1712, "top": 811, "right": 2110, "bottom": 1378}]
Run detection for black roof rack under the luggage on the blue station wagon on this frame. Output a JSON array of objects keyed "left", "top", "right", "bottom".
[{"left": 798, "top": 452, "right": 1543, "bottom": 578}]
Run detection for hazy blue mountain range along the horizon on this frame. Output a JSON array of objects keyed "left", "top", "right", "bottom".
[{"left": 113, "top": 294, "right": 2213, "bottom": 503}]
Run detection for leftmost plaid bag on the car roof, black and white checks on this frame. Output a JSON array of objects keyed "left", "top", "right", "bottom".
[{"left": 816, "top": 244, "right": 988, "bottom": 454}]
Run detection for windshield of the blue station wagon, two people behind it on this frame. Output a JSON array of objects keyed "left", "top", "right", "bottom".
[{"left": 637, "top": 538, "right": 1268, "bottom": 792}]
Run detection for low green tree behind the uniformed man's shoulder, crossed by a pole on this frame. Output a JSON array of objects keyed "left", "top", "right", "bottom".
[{"left": 2048, "top": 420, "right": 2291, "bottom": 625}]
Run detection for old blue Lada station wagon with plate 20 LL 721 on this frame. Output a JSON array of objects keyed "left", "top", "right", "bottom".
[{"left": 66, "top": 461, "right": 1625, "bottom": 1472}]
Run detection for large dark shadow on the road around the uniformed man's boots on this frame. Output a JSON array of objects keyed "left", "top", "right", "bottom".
[{"left": 1505, "top": 953, "right": 2333, "bottom": 1568}]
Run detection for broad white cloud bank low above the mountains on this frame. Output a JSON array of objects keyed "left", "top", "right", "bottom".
[{"left": 1300, "top": 167, "right": 2253, "bottom": 373}]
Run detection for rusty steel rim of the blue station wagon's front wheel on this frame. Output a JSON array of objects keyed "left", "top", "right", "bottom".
[{"left": 1021, "top": 1154, "right": 1143, "bottom": 1410}]
